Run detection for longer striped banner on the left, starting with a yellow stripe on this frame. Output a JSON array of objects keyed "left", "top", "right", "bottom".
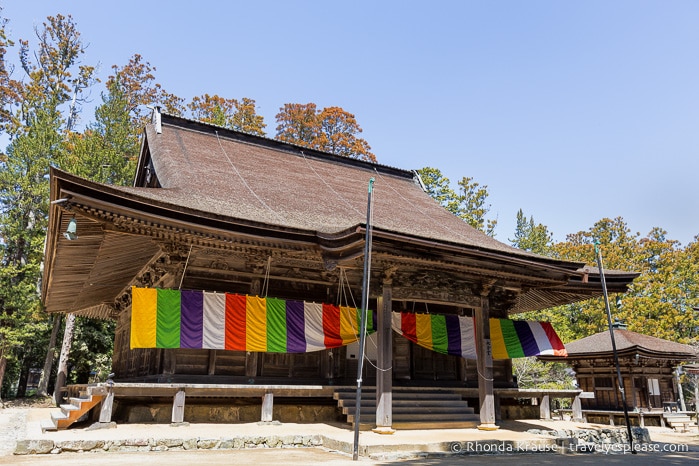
[{"left": 131, "top": 287, "right": 376, "bottom": 353}]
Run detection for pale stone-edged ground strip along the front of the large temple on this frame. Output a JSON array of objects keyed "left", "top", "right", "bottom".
[{"left": 0, "top": 406, "right": 699, "bottom": 458}]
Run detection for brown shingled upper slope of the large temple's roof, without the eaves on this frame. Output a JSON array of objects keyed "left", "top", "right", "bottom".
[{"left": 123, "top": 115, "right": 540, "bottom": 256}]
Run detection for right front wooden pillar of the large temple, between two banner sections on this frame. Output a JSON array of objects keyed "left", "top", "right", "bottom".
[{"left": 475, "top": 289, "right": 498, "bottom": 430}]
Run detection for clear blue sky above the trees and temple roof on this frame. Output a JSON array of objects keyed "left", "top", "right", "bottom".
[{"left": 0, "top": 0, "right": 699, "bottom": 245}]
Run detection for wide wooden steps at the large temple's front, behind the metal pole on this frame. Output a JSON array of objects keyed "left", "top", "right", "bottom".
[{"left": 333, "top": 387, "right": 480, "bottom": 430}]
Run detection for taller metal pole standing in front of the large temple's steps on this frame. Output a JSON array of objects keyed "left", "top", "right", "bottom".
[{"left": 352, "top": 178, "right": 374, "bottom": 461}]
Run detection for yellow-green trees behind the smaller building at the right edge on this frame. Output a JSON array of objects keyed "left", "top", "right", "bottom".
[{"left": 522, "top": 217, "right": 699, "bottom": 343}]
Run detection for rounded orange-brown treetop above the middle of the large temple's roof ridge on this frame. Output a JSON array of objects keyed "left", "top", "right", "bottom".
[{"left": 276, "top": 103, "right": 376, "bottom": 162}]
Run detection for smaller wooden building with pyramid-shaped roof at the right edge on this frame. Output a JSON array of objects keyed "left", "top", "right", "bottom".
[{"left": 539, "top": 323, "right": 698, "bottom": 411}]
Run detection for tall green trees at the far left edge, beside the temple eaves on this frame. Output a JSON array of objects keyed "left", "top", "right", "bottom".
[{"left": 0, "top": 15, "right": 94, "bottom": 400}]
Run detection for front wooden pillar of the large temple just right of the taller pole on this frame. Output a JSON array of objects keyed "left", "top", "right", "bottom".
[{"left": 374, "top": 282, "right": 395, "bottom": 434}]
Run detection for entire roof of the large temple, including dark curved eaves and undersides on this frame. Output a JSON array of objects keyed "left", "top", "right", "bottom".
[{"left": 42, "top": 113, "right": 637, "bottom": 317}]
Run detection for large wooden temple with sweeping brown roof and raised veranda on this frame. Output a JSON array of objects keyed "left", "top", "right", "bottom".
[{"left": 42, "top": 111, "right": 636, "bottom": 429}]
